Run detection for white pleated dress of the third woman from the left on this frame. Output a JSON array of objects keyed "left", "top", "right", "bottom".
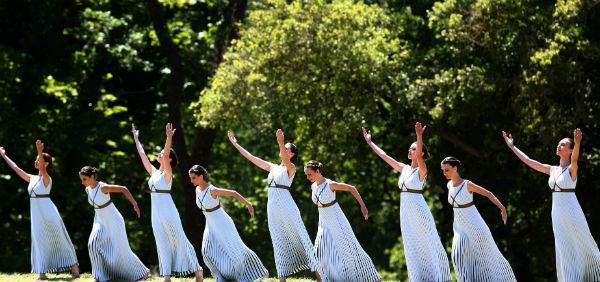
[{"left": 148, "top": 169, "right": 202, "bottom": 276}]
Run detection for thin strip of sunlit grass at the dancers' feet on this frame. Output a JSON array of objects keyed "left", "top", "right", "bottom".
[{"left": 0, "top": 273, "right": 314, "bottom": 282}]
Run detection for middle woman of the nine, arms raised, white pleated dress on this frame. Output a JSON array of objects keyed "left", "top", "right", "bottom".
[{"left": 228, "top": 129, "right": 320, "bottom": 281}]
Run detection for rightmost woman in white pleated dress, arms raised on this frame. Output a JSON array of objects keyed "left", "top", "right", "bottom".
[{"left": 502, "top": 128, "right": 600, "bottom": 282}]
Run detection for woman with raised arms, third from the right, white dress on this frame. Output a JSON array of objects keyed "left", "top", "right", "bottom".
[{"left": 362, "top": 122, "right": 451, "bottom": 282}]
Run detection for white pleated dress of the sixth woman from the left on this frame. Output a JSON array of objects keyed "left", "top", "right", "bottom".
[{"left": 311, "top": 179, "right": 381, "bottom": 282}]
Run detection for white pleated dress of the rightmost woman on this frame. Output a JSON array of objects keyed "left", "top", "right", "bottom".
[{"left": 548, "top": 166, "right": 600, "bottom": 282}]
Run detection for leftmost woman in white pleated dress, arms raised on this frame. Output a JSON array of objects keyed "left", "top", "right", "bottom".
[{"left": 0, "top": 140, "right": 79, "bottom": 280}]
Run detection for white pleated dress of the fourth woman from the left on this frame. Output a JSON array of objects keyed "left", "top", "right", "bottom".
[{"left": 196, "top": 185, "right": 269, "bottom": 282}]
